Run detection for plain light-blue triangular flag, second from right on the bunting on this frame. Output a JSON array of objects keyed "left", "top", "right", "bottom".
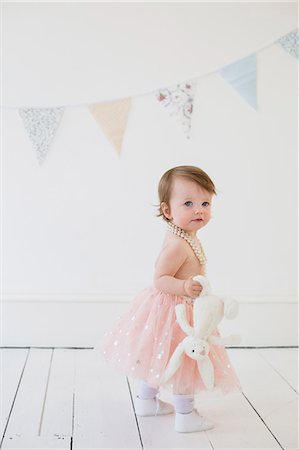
[{"left": 219, "top": 54, "right": 257, "bottom": 109}]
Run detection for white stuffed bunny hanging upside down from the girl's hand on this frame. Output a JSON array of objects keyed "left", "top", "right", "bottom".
[{"left": 161, "top": 275, "right": 240, "bottom": 389}]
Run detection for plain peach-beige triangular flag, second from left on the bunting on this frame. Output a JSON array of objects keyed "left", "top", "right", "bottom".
[{"left": 88, "top": 97, "right": 131, "bottom": 154}]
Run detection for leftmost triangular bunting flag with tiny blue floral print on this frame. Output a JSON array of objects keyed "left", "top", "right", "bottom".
[{"left": 19, "top": 108, "right": 64, "bottom": 164}]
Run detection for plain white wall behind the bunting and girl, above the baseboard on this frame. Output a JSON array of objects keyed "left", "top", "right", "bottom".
[{"left": 2, "top": 2, "right": 297, "bottom": 344}]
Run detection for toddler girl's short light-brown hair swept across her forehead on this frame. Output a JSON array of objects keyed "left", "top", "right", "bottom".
[{"left": 157, "top": 166, "right": 217, "bottom": 221}]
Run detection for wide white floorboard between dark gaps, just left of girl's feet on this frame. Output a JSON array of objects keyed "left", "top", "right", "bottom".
[{"left": 73, "top": 350, "right": 141, "bottom": 450}]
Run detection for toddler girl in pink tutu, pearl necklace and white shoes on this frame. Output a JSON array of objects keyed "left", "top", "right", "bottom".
[{"left": 102, "top": 166, "right": 239, "bottom": 432}]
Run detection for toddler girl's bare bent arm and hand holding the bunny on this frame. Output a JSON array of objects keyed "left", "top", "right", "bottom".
[{"left": 154, "top": 241, "right": 201, "bottom": 298}]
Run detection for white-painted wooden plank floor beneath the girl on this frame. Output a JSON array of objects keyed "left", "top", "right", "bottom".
[{"left": 0, "top": 348, "right": 298, "bottom": 450}]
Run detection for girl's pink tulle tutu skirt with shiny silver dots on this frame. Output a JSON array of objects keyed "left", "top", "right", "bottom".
[{"left": 99, "top": 287, "right": 240, "bottom": 394}]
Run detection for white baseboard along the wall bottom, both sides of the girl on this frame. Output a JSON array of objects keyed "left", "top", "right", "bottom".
[{"left": 1, "top": 297, "right": 298, "bottom": 347}]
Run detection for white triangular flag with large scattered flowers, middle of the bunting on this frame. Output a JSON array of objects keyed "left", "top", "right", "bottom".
[{"left": 156, "top": 81, "right": 196, "bottom": 139}]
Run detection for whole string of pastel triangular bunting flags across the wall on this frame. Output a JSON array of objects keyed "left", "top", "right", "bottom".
[{"left": 7, "top": 30, "right": 299, "bottom": 164}]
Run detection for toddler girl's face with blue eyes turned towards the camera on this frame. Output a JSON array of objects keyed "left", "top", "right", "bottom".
[{"left": 161, "top": 176, "right": 213, "bottom": 237}]
